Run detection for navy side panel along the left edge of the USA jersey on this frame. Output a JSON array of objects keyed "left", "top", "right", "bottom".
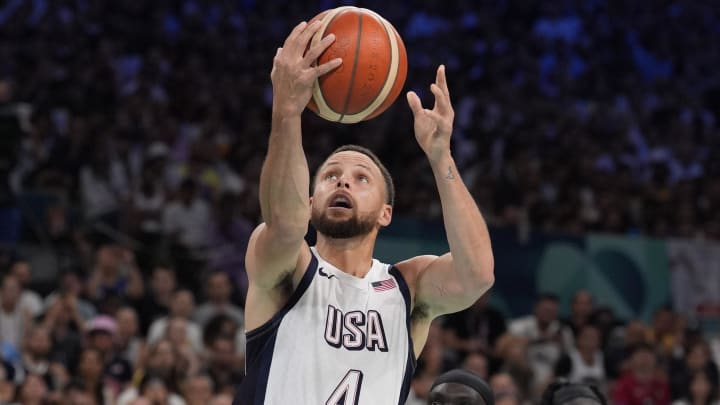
[{"left": 233, "top": 255, "right": 318, "bottom": 405}]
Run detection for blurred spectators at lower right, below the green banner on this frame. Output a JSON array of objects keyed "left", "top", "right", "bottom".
[{"left": 406, "top": 290, "right": 720, "bottom": 405}]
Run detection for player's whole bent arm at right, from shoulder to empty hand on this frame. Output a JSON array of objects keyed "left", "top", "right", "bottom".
[{"left": 404, "top": 66, "right": 495, "bottom": 317}]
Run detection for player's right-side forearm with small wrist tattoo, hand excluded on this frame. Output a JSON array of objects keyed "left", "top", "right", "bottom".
[{"left": 431, "top": 153, "right": 494, "bottom": 289}]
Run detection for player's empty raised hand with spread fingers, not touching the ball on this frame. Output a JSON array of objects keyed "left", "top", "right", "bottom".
[{"left": 407, "top": 65, "right": 455, "bottom": 163}]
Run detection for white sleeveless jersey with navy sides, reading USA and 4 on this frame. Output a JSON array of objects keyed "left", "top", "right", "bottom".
[{"left": 234, "top": 248, "right": 415, "bottom": 405}]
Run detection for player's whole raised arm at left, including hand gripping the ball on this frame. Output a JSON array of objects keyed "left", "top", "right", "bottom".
[{"left": 246, "top": 22, "right": 340, "bottom": 289}]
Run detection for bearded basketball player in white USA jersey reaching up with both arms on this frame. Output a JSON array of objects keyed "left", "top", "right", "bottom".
[{"left": 235, "top": 23, "right": 494, "bottom": 405}]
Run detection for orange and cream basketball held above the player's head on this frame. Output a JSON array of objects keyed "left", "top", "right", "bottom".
[{"left": 308, "top": 7, "right": 407, "bottom": 124}]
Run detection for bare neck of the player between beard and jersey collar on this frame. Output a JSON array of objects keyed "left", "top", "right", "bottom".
[{"left": 315, "top": 233, "right": 376, "bottom": 278}]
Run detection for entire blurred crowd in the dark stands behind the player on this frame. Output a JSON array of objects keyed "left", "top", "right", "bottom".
[{"left": 0, "top": 0, "right": 720, "bottom": 405}]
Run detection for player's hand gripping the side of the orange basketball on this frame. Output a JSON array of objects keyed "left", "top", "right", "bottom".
[{"left": 270, "top": 21, "right": 342, "bottom": 115}]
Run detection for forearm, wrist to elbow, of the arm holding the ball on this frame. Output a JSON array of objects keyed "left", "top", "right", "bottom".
[{"left": 260, "top": 111, "right": 310, "bottom": 236}]
